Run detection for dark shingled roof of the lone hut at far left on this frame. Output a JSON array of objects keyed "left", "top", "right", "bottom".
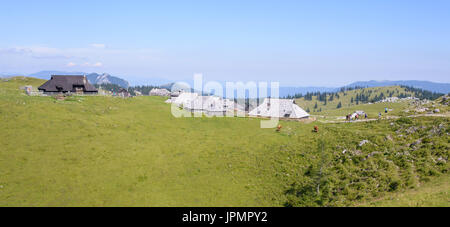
[{"left": 38, "top": 75, "right": 98, "bottom": 92}]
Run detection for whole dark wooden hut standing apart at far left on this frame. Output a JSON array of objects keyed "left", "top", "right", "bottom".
[{"left": 38, "top": 75, "right": 98, "bottom": 95}]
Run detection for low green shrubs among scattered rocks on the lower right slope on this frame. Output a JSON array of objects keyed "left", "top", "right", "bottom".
[{"left": 285, "top": 118, "right": 449, "bottom": 206}]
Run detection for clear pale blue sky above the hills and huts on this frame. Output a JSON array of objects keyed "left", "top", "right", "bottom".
[{"left": 0, "top": 0, "right": 450, "bottom": 86}]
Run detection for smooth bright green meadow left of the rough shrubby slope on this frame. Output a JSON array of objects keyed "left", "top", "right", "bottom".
[{"left": 0, "top": 79, "right": 308, "bottom": 206}]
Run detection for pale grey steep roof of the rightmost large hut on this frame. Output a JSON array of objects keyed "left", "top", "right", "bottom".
[{"left": 249, "top": 98, "right": 309, "bottom": 118}]
